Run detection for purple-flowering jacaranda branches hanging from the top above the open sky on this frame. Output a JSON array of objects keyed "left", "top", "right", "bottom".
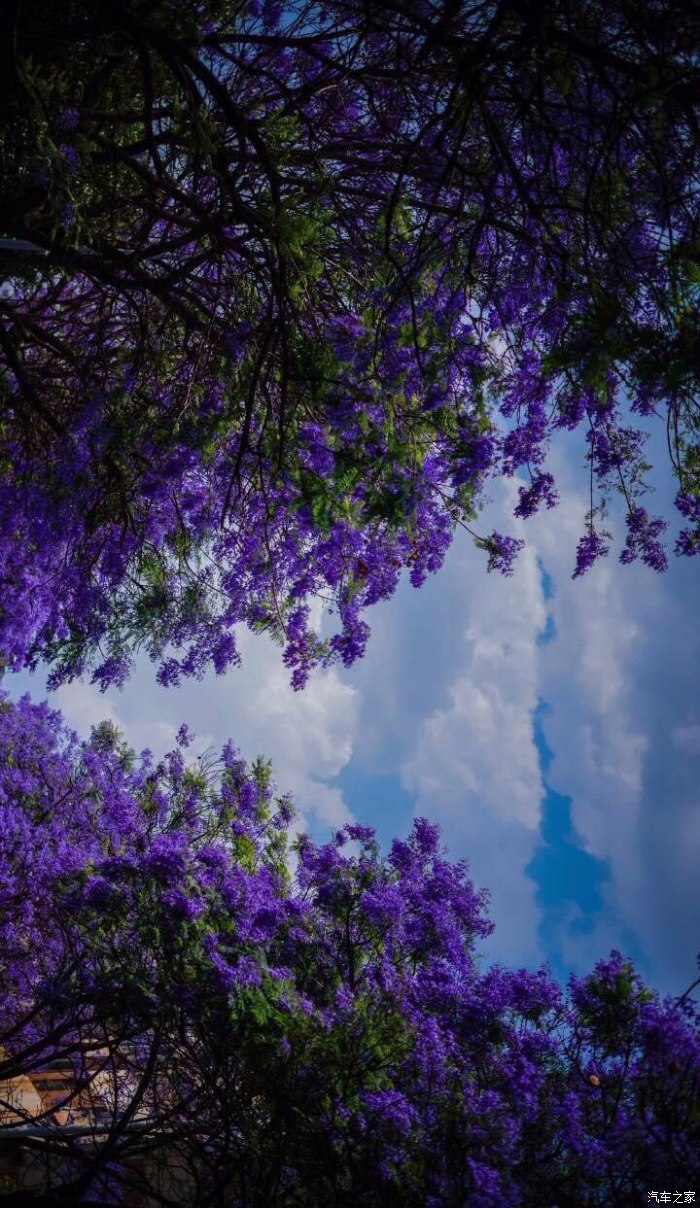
[{"left": 0, "top": 0, "right": 700, "bottom": 686}]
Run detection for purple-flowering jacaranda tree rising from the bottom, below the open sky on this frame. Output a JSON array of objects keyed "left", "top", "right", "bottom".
[{"left": 0, "top": 697, "right": 700, "bottom": 1208}]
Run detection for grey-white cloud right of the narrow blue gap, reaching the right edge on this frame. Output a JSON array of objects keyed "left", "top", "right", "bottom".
[{"left": 533, "top": 454, "right": 700, "bottom": 989}]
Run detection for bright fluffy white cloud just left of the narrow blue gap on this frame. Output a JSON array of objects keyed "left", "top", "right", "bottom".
[{"left": 401, "top": 489, "right": 546, "bottom": 963}]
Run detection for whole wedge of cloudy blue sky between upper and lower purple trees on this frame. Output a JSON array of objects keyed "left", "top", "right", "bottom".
[{"left": 6, "top": 446, "right": 700, "bottom": 993}]
